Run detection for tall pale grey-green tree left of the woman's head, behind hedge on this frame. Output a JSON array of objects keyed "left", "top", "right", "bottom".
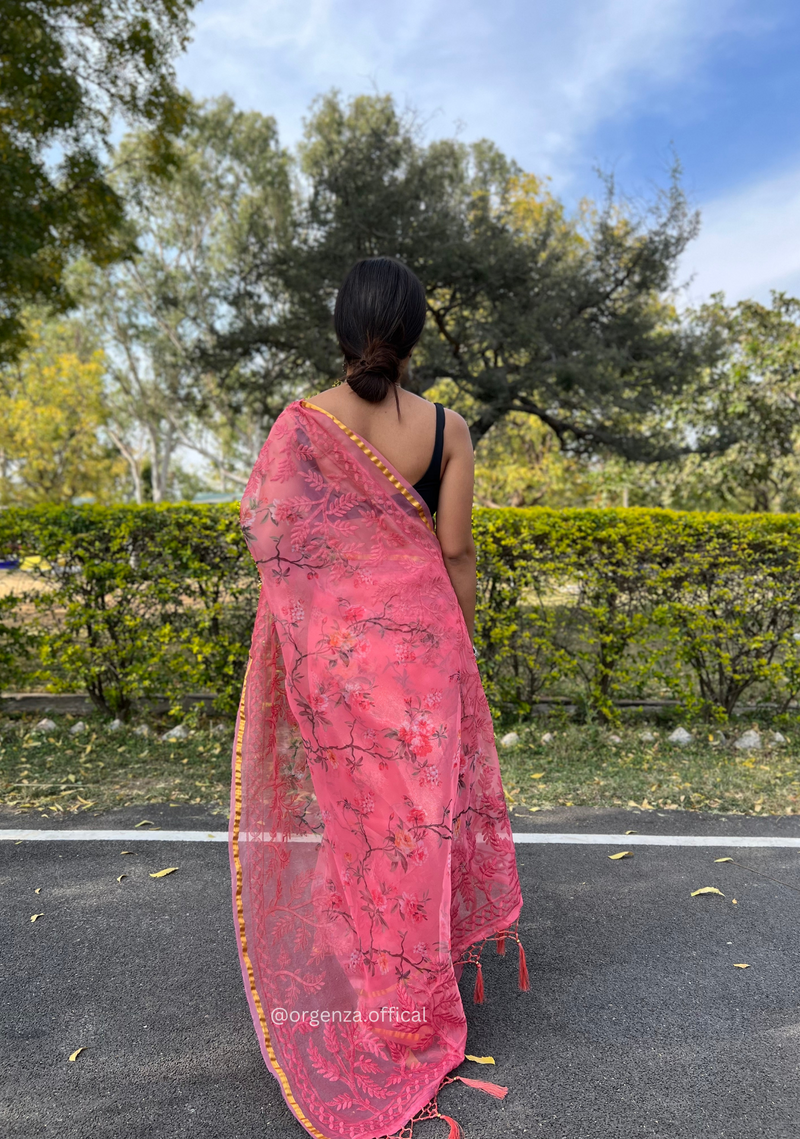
[{"left": 75, "top": 98, "right": 297, "bottom": 501}]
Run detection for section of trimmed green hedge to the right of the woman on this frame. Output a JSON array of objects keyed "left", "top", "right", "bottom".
[{"left": 475, "top": 509, "right": 800, "bottom": 719}]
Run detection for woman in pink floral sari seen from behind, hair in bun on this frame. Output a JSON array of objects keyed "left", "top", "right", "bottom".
[{"left": 229, "top": 257, "right": 528, "bottom": 1139}]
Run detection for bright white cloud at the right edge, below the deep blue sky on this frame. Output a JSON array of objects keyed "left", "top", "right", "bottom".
[{"left": 683, "top": 166, "right": 800, "bottom": 303}]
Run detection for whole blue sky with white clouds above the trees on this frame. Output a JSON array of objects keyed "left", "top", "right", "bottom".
[{"left": 179, "top": 0, "right": 800, "bottom": 301}]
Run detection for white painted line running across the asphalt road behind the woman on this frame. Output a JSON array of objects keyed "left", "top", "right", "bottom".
[{"left": 0, "top": 828, "right": 800, "bottom": 849}]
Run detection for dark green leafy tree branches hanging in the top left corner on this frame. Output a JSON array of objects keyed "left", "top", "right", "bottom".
[{"left": 0, "top": 0, "right": 195, "bottom": 357}]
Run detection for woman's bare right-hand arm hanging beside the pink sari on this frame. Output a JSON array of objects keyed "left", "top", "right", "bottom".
[{"left": 436, "top": 410, "right": 477, "bottom": 640}]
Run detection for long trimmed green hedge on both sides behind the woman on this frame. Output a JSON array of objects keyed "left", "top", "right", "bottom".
[{"left": 0, "top": 505, "right": 800, "bottom": 719}]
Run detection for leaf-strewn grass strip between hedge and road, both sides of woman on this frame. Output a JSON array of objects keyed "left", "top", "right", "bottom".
[{"left": 0, "top": 715, "right": 800, "bottom": 817}]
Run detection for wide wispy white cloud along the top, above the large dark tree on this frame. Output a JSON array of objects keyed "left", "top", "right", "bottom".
[{"left": 180, "top": 0, "right": 743, "bottom": 186}]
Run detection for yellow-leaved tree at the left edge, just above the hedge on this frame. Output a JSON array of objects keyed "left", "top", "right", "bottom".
[{"left": 0, "top": 320, "right": 122, "bottom": 506}]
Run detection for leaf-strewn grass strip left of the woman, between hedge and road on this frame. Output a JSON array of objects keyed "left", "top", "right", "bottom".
[{"left": 0, "top": 716, "right": 234, "bottom": 816}]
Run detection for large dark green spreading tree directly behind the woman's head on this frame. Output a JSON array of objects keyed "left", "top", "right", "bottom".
[{"left": 201, "top": 92, "right": 727, "bottom": 461}]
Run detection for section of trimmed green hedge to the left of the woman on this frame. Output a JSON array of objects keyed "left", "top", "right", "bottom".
[{"left": 0, "top": 506, "right": 258, "bottom": 716}]
